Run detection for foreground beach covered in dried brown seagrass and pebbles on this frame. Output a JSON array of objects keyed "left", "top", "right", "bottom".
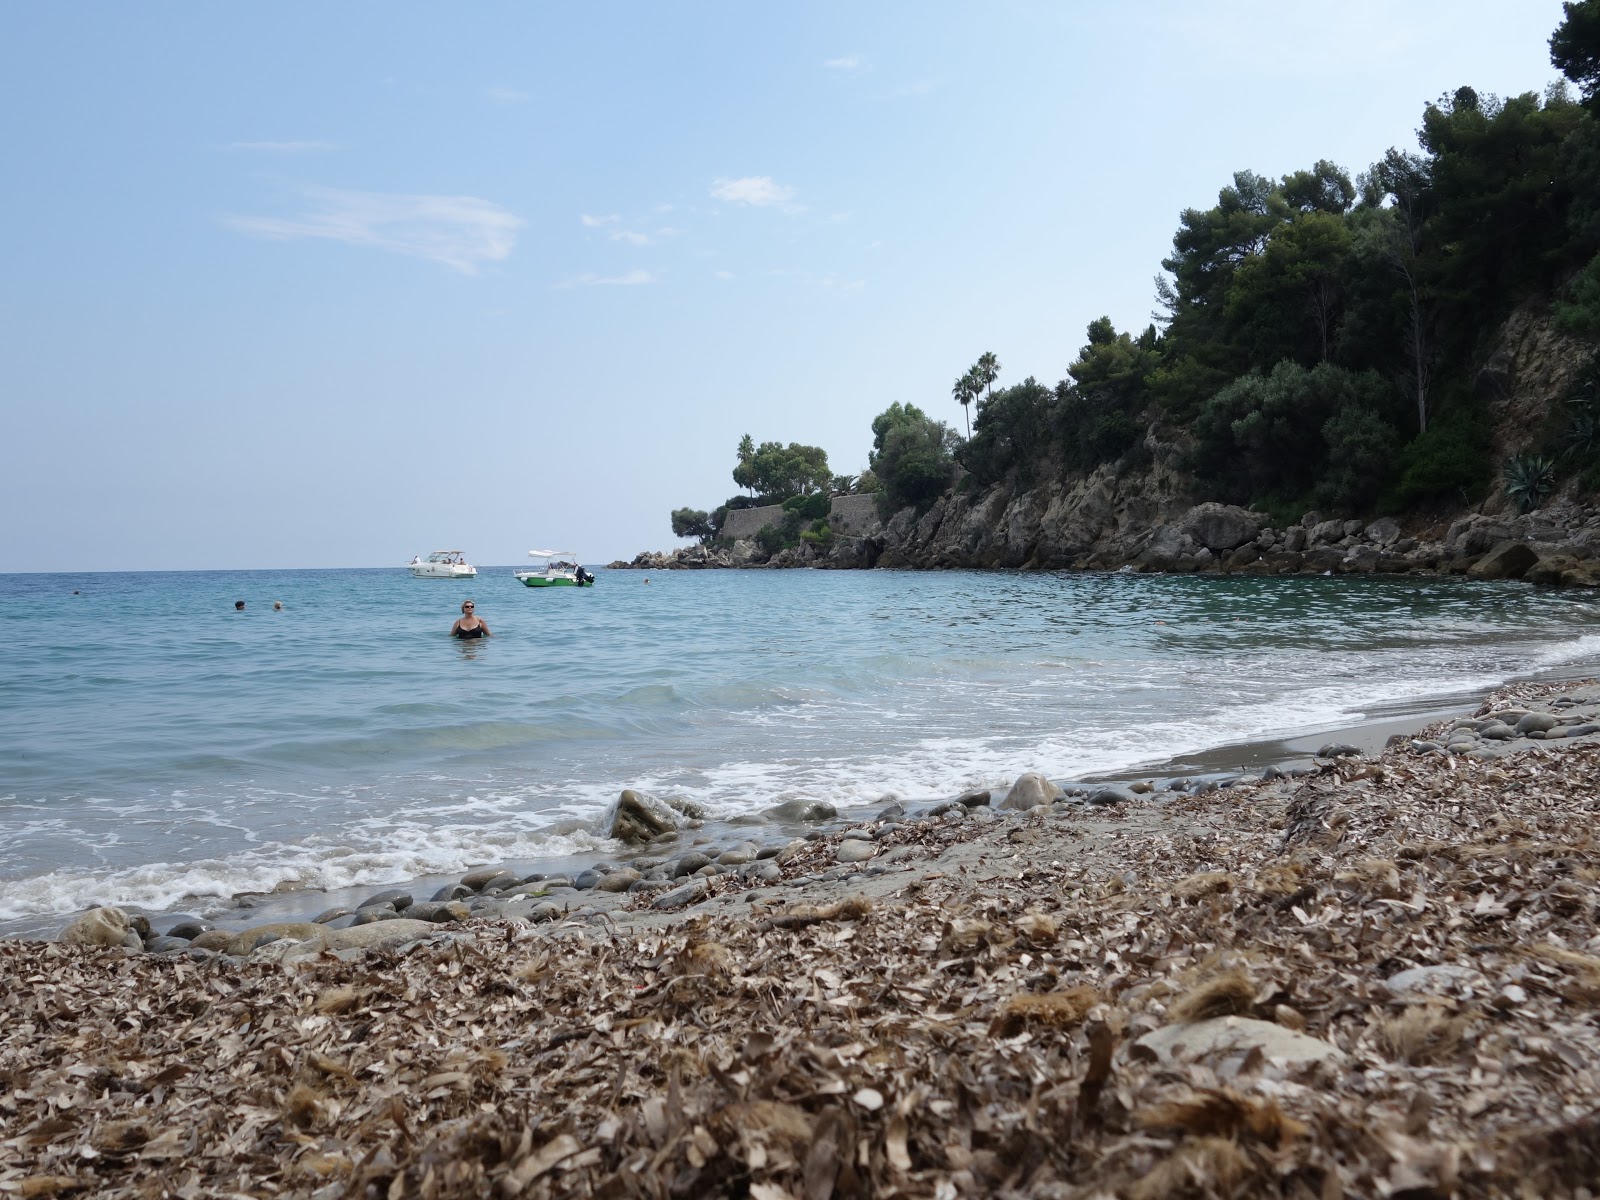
[{"left": 9, "top": 685, "right": 1600, "bottom": 1200}]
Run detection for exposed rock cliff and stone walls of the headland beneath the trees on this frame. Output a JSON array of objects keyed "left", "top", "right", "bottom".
[{"left": 613, "top": 302, "right": 1600, "bottom": 584}]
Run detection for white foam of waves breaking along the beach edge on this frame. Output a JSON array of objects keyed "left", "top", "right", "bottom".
[{"left": 12, "top": 634, "right": 1600, "bottom": 931}]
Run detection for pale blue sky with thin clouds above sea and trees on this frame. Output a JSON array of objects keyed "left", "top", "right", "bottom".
[{"left": 0, "top": 0, "right": 1562, "bottom": 571}]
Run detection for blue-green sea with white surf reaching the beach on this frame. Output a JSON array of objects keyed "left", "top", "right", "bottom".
[{"left": 0, "top": 566, "right": 1600, "bottom": 936}]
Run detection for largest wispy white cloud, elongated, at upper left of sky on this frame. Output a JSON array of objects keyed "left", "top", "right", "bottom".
[{"left": 222, "top": 187, "right": 523, "bottom": 275}]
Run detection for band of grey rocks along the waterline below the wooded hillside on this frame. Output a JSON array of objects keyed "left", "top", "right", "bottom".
[{"left": 610, "top": 496, "right": 1600, "bottom": 587}]
